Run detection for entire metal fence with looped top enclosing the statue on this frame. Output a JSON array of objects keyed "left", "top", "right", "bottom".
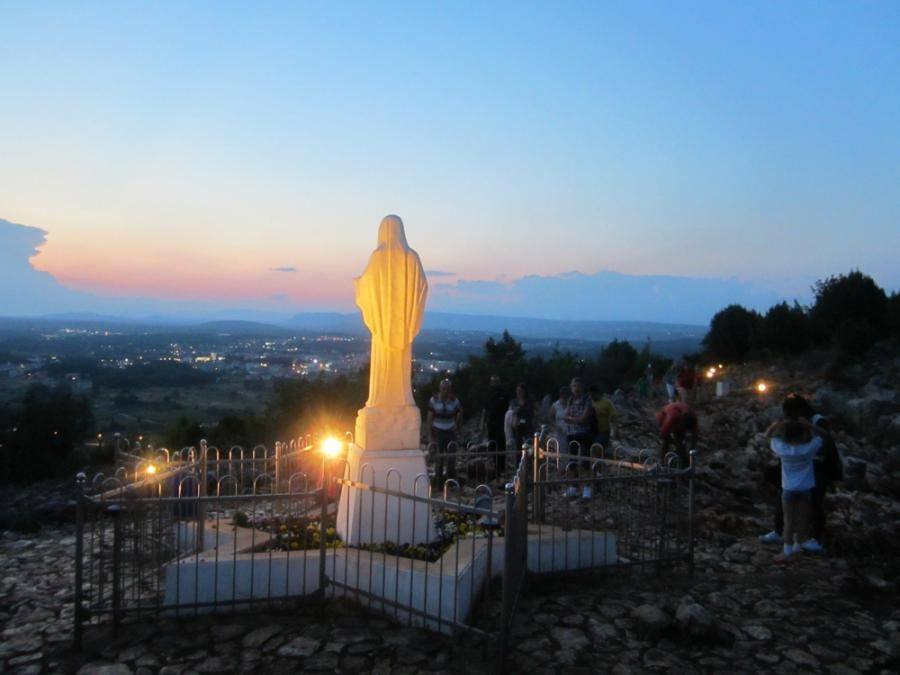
[{"left": 75, "top": 436, "right": 694, "bottom": 660}]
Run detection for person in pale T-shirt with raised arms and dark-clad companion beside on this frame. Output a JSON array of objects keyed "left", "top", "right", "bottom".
[{"left": 760, "top": 394, "right": 843, "bottom": 563}]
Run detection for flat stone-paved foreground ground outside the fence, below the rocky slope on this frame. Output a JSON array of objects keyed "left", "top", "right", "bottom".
[{"left": 0, "top": 525, "right": 900, "bottom": 675}]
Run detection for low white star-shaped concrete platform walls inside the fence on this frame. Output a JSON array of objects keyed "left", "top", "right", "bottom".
[{"left": 164, "top": 525, "right": 617, "bottom": 633}]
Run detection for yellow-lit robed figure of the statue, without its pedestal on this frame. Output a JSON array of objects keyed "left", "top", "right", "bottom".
[{"left": 355, "top": 216, "right": 428, "bottom": 407}]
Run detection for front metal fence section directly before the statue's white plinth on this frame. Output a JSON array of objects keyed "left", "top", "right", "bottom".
[{"left": 325, "top": 466, "right": 502, "bottom": 632}]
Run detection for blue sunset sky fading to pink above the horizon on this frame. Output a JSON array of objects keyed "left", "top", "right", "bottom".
[{"left": 0, "top": 1, "right": 900, "bottom": 318}]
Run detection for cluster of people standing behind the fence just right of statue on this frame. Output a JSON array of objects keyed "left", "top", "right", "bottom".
[{"left": 425, "top": 375, "right": 616, "bottom": 485}]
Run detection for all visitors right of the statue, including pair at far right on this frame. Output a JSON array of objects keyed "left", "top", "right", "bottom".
[{"left": 426, "top": 365, "right": 842, "bottom": 563}]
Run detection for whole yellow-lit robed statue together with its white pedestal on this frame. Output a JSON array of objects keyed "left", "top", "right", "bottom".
[{"left": 337, "top": 216, "right": 435, "bottom": 546}]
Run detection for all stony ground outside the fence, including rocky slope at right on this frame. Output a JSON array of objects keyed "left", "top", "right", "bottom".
[{"left": 0, "top": 356, "right": 900, "bottom": 675}]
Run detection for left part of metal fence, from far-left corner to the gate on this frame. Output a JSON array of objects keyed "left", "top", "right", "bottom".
[{"left": 75, "top": 442, "right": 500, "bottom": 645}]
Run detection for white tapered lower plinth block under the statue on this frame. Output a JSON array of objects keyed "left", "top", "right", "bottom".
[{"left": 337, "top": 444, "right": 435, "bottom": 546}]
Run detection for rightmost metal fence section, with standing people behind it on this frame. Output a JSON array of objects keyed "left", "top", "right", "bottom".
[{"left": 529, "top": 442, "right": 694, "bottom": 574}]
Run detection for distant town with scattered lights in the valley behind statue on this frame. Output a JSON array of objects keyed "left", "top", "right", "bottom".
[{"left": 0, "top": 319, "right": 699, "bottom": 442}]
